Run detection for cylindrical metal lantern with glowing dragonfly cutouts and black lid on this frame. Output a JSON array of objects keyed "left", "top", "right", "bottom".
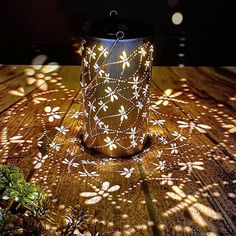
[{"left": 81, "top": 12, "right": 153, "bottom": 156}]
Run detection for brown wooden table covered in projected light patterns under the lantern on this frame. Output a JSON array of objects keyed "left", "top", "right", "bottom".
[{"left": 0, "top": 66, "right": 236, "bottom": 236}]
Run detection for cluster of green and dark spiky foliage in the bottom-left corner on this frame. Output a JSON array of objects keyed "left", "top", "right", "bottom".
[{"left": 0, "top": 165, "right": 110, "bottom": 236}]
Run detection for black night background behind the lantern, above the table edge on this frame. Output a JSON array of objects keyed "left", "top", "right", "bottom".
[{"left": 0, "top": 0, "right": 236, "bottom": 66}]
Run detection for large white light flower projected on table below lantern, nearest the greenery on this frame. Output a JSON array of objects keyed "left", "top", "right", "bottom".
[{"left": 80, "top": 181, "right": 120, "bottom": 205}]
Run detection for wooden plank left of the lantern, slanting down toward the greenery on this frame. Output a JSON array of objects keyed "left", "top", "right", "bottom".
[{"left": 1, "top": 67, "right": 80, "bottom": 171}]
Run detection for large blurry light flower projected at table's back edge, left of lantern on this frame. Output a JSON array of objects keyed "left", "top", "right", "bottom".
[{"left": 25, "top": 55, "right": 61, "bottom": 91}]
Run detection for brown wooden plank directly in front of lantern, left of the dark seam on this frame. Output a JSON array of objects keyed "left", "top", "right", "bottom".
[{"left": 26, "top": 90, "right": 158, "bottom": 235}]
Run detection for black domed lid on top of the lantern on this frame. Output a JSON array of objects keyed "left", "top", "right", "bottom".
[{"left": 87, "top": 16, "right": 152, "bottom": 40}]
